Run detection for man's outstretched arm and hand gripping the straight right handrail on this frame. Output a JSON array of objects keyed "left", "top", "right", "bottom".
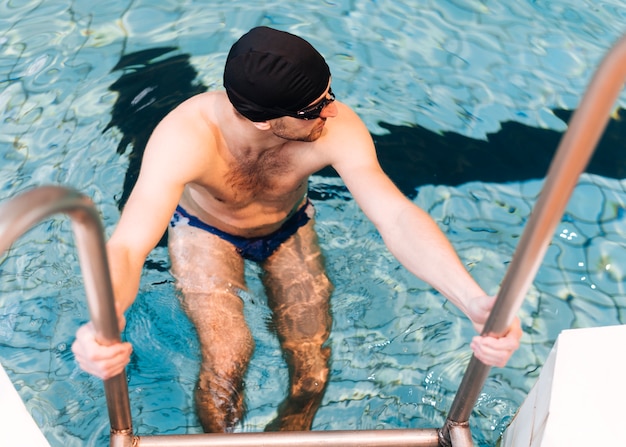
[{"left": 333, "top": 106, "right": 522, "bottom": 366}]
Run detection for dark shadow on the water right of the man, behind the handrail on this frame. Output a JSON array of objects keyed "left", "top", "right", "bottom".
[{"left": 366, "top": 109, "right": 626, "bottom": 196}]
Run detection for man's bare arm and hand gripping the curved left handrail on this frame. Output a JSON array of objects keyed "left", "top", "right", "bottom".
[{"left": 72, "top": 103, "right": 206, "bottom": 379}]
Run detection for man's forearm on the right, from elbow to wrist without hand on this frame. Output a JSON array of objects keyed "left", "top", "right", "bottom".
[{"left": 381, "top": 203, "right": 485, "bottom": 316}]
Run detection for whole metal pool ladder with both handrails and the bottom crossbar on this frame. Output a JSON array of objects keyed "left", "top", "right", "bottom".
[{"left": 0, "top": 32, "right": 626, "bottom": 447}]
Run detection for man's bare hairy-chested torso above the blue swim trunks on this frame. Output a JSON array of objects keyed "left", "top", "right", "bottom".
[{"left": 169, "top": 93, "right": 325, "bottom": 237}]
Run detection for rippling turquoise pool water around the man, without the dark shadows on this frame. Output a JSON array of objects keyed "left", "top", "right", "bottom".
[{"left": 0, "top": 0, "right": 626, "bottom": 447}]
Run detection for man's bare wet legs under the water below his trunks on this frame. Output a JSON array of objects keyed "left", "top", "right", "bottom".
[{"left": 169, "top": 208, "right": 332, "bottom": 432}]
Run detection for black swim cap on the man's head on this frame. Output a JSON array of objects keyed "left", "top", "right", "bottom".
[{"left": 224, "top": 26, "right": 330, "bottom": 122}]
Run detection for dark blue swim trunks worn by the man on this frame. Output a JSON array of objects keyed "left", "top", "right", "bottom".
[{"left": 170, "top": 199, "right": 313, "bottom": 262}]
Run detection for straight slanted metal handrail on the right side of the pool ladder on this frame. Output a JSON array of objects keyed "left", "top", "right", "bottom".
[{"left": 440, "top": 35, "right": 626, "bottom": 447}]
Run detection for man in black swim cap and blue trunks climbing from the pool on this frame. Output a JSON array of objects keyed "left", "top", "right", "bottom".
[{"left": 73, "top": 27, "right": 521, "bottom": 432}]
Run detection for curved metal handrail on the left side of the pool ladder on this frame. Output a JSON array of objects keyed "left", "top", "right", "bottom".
[{"left": 0, "top": 186, "right": 133, "bottom": 447}]
